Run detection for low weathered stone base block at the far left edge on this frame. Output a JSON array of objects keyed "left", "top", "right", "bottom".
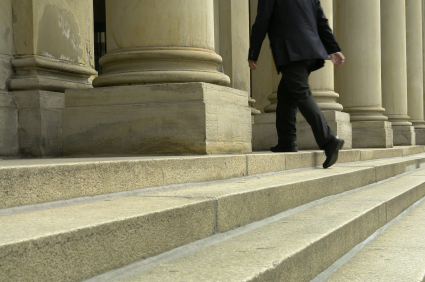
[{"left": 0, "top": 90, "right": 19, "bottom": 156}]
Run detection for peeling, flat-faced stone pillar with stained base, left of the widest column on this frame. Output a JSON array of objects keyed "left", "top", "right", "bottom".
[{"left": 2, "top": 0, "right": 97, "bottom": 156}]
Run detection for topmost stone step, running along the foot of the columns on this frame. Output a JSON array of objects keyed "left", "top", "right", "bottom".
[{"left": 0, "top": 146, "right": 425, "bottom": 208}]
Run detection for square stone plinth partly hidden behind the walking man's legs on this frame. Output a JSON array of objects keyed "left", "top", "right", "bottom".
[{"left": 297, "top": 111, "right": 353, "bottom": 150}]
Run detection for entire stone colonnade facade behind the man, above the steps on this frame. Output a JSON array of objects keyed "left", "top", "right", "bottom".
[{"left": 0, "top": 0, "right": 425, "bottom": 156}]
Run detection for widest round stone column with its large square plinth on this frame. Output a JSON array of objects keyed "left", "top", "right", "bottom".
[{"left": 63, "top": 0, "right": 252, "bottom": 155}]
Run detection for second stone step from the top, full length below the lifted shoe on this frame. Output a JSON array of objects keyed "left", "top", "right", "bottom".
[{"left": 0, "top": 153, "right": 425, "bottom": 281}]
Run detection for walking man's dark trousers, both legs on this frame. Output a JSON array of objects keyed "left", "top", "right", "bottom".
[{"left": 276, "top": 60, "right": 335, "bottom": 149}]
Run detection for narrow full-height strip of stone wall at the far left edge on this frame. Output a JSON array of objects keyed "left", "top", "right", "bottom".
[{"left": 0, "top": 0, "right": 19, "bottom": 156}]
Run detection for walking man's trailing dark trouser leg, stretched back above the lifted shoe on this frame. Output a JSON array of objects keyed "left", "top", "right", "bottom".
[{"left": 278, "top": 60, "right": 335, "bottom": 149}]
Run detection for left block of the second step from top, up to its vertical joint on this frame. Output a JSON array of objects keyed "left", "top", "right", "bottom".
[{"left": 0, "top": 196, "right": 215, "bottom": 281}]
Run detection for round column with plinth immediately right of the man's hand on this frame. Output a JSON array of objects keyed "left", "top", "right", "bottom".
[{"left": 335, "top": 0, "right": 393, "bottom": 148}]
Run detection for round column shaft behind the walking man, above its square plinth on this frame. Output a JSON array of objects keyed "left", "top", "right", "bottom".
[{"left": 310, "top": 0, "right": 343, "bottom": 111}]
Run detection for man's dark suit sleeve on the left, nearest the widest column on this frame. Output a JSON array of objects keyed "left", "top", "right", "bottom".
[{"left": 248, "top": 0, "right": 276, "bottom": 61}]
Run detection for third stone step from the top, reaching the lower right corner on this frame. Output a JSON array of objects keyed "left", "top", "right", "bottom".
[{"left": 93, "top": 169, "right": 425, "bottom": 282}]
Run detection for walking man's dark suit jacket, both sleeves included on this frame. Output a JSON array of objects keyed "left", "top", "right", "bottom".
[{"left": 248, "top": 0, "right": 341, "bottom": 70}]
